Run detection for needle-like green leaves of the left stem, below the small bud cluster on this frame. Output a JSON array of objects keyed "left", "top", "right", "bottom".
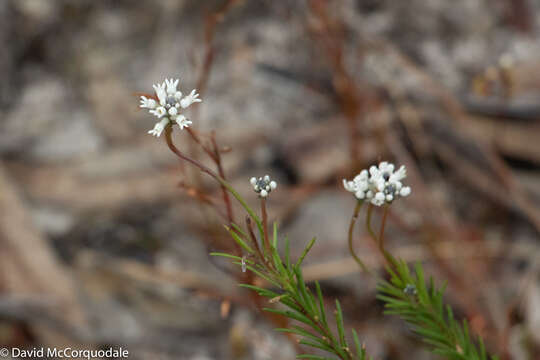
[{"left": 212, "top": 224, "right": 368, "bottom": 360}]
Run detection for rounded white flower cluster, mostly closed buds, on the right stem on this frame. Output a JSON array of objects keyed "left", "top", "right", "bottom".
[{"left": 343, "top": 161, "right": 411, "bottom": 206}]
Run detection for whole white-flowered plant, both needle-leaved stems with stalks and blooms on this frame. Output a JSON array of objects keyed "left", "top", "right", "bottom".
[{"left": 140, "top": 79, "right": 498, "bottom": 360}]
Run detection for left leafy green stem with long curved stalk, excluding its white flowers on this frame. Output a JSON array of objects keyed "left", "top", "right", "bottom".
[{"left": 165, "top": 126, "right": 367, "bottom": 360}]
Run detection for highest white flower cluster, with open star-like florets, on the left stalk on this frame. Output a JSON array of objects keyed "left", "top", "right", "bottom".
[{"left": 140, "top": 79, "right": 202, "bottom": 136}]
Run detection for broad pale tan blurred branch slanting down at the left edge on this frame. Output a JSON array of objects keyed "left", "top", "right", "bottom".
[{"left": 0, "top": 164, "right": 88, "bottom": 346}]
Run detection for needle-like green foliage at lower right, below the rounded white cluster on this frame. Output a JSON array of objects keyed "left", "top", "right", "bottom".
[{"left": 377, "top": 260, "right": 496, "bottom": 360}]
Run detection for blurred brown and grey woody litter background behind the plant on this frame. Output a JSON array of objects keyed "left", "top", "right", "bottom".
[{"left": 0, "top": 0, "right": 540, "bottom": 360}]
